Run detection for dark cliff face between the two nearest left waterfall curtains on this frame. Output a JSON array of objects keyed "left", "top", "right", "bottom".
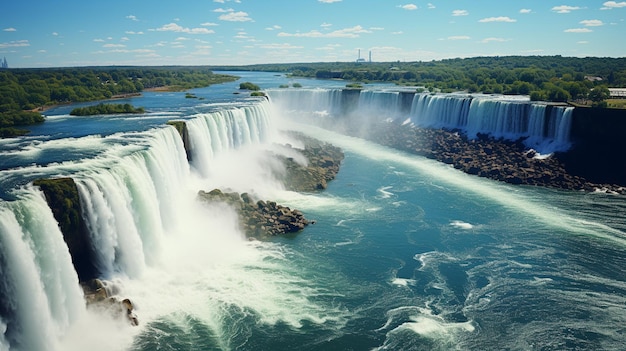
[{"left": 33, "top": 178, "right": 98, "bottom": 281}]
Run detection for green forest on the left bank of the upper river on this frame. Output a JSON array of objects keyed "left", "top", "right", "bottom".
[{"left": 0, "top": 67, "right": 237, "bottom": 136}]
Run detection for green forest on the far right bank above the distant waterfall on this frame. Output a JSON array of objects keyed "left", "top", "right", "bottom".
[{"left": 212, "top": 56, "right": 626, "bottom": 101}]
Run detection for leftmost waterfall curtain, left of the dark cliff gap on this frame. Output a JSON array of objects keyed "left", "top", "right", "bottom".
[{"left": 0, "top": 187, "right": 85, "bottom": 351}]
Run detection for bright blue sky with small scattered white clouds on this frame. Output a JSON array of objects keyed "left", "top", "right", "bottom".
[{"left": 0, "top": 0, "right": 626, "bottom": 67}]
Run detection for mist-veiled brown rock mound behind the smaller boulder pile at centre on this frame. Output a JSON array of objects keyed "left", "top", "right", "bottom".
[{"left": 277, "top": 132, "right": 344, "bottom": 192}]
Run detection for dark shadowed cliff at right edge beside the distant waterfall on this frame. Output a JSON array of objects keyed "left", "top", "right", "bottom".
[{"left": 557, "top": 108, "right": 626, "bottom": 186}]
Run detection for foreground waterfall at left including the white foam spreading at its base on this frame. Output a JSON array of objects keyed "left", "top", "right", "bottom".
[{"left": 0, "top": 97, "right": 337, "bottom": 351}]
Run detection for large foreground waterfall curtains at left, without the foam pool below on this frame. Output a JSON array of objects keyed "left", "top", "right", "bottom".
[{"left": 0, "top": 101, "right": 272, "bottom": 351}]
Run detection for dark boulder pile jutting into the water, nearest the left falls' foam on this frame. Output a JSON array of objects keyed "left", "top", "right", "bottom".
[{"left": 198, "top": 189, "right": 311, "bottom": 239}]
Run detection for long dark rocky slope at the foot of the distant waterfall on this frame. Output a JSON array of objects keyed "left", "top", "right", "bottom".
[{"left": 360, "top": 123, "right": 626, "bottom": 195}]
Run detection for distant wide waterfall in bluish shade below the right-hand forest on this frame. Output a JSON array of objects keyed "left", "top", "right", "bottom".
[{"left": 270, "top": 89, "right": 573, "bottom": 154}]
